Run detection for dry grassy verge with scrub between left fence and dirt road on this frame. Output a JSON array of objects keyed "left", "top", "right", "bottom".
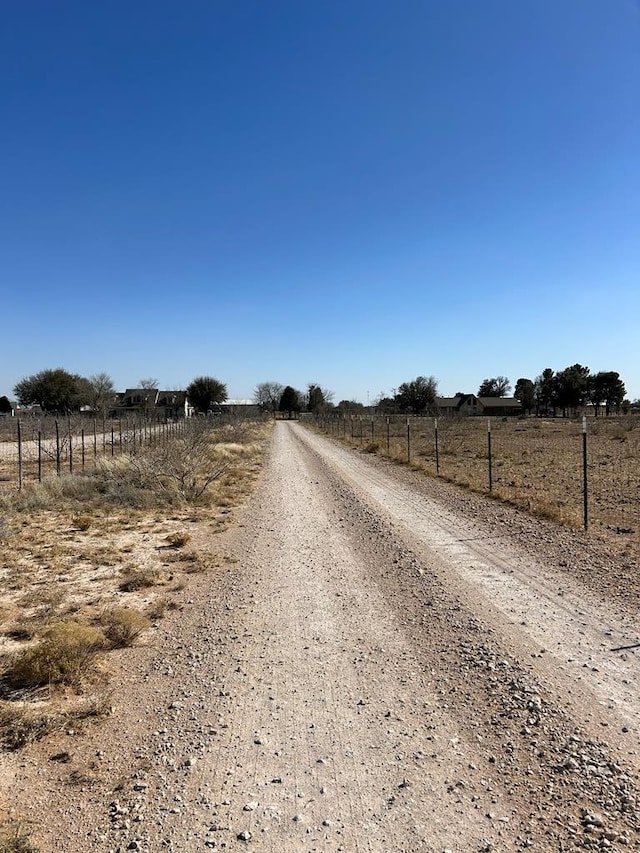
[{"left": 0, "top": 416, "right": 271, "bottom": 756}]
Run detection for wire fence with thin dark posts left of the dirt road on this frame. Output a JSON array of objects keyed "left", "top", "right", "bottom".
[{"left": 0, "top": 416, "right": 245, "bottom": 489}]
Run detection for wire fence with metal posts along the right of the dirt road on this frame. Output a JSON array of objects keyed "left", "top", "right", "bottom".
[{"left": 316, "top": 413, "right": 640, "bottom": 557}]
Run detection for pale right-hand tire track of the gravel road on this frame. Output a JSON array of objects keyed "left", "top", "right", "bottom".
[{"left": 300, "top": 426, "right": 640, "bottom": 737}]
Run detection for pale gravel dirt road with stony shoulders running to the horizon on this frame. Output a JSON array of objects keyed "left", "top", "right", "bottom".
[{"left": 3, "top": 423, "right": 640, "bottom": 853}]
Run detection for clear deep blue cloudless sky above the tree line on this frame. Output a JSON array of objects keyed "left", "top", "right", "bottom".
[{"left": 0, "top": 0, "right": 640, "bottom": 402}]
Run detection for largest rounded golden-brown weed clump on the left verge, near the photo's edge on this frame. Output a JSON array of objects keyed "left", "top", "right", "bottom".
[{"left": 6, "top": 622, "right": 104, "bottom": 689}]
